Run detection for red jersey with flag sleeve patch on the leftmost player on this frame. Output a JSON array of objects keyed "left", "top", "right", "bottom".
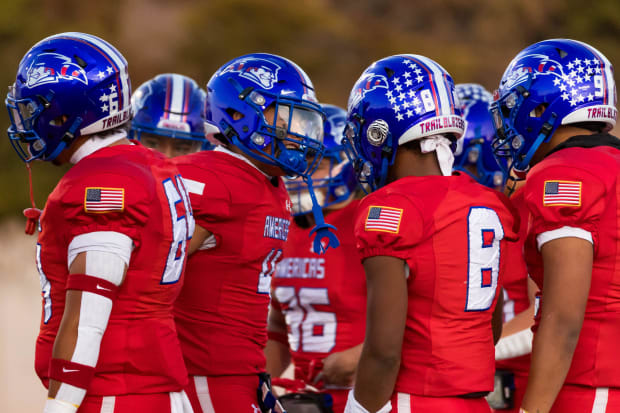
[{"left": 35, "top": 145, "right": 193, "bottom": 396}]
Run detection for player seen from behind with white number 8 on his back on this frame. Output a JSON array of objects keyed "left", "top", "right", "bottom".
[{"left": 345, "top": 55, "right": 516, "bottom": 413}]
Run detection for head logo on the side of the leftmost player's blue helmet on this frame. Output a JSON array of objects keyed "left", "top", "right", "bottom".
[{"left": 26, "top": 53, "right": 88, "bottom": 88}]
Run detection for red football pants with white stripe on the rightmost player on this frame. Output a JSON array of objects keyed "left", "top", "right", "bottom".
[{"left": 551, "top": 384, "right": 620, "bottom": 413}]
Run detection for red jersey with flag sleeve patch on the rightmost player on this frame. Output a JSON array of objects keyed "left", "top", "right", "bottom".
[{"left": 525, "top": 135, "right": 620, "bottom": 387}]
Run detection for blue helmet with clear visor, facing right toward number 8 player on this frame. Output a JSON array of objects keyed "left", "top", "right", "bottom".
[{"left": 206, "top": 53, "right": 324, "bottom": 177}]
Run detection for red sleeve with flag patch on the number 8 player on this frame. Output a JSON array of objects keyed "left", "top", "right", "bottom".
[{"left": 355, "top": 194, "right": 424, "bottom": 260}]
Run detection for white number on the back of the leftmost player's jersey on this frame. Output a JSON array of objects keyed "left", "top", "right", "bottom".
[{"left": 161, "top": 175, "right": 195, "bottom": 284}]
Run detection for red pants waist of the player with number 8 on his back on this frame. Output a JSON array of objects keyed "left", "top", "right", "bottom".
[{"left": 392, "top": 393, "right": 491, "bottom": 413}]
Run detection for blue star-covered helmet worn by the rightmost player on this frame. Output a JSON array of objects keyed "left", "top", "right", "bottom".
[{"left": 491, "top": 39, "right": 617, "bottom": 171}]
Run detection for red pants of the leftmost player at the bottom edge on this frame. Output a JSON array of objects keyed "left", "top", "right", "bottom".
[{"left": 77, "top": 391, "right": 192, "bottom": 413}]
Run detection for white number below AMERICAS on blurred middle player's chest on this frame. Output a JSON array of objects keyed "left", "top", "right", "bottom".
[{"left": 275, "top": 287, "right": 337, "bottom": 353}]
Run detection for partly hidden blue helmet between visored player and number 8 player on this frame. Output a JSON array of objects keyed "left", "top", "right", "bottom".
[{"left": 286, "top": 104, "right": 357, "bottom": 216}]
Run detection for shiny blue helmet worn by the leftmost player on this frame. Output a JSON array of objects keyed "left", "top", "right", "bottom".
[{"left": 5, "top": 33, "right": 131, "bottom": 162}]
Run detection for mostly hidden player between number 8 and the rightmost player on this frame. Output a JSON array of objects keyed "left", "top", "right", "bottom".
[{"left": 453, "top": 83, "right": 537, "bottom": 412}]
